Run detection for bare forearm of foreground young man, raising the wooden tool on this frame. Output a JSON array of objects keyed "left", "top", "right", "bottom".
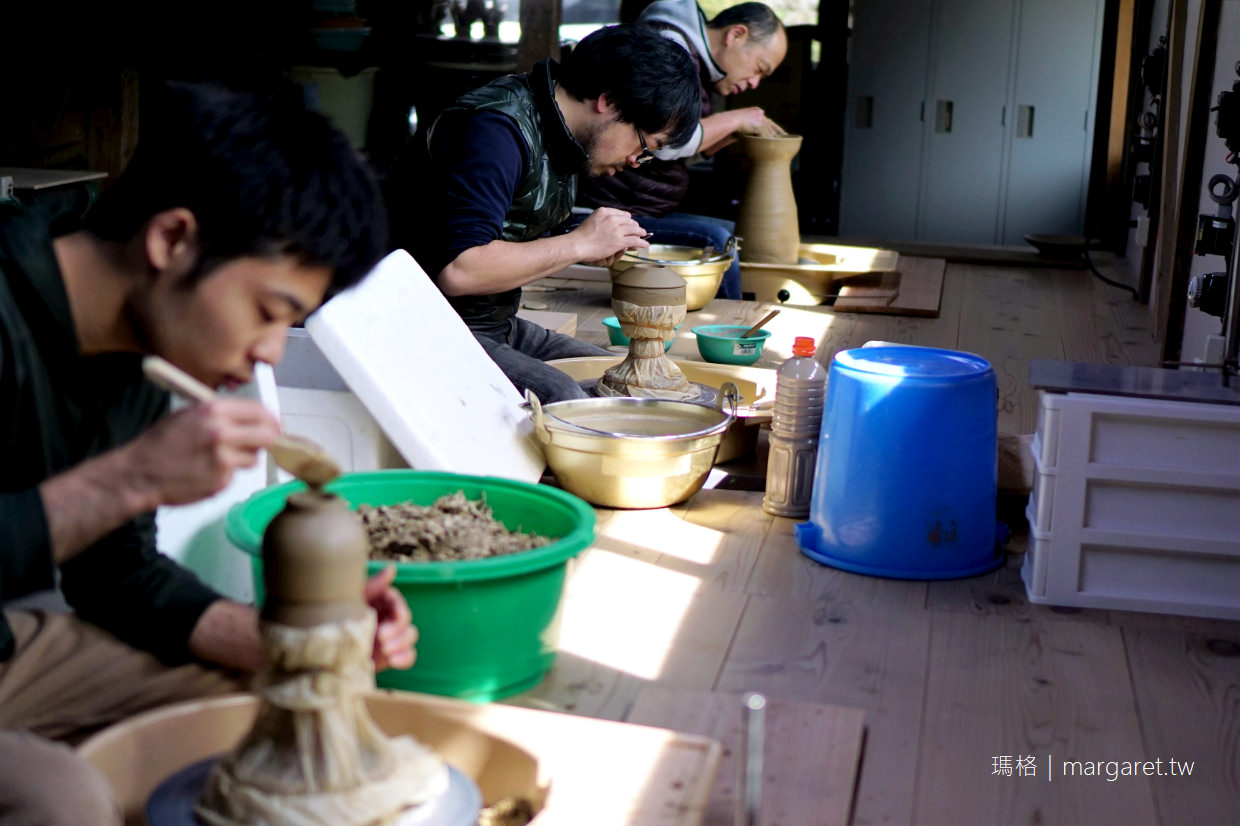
[{"left": 38, "top": 449, "right": 159, "bottom": 564}]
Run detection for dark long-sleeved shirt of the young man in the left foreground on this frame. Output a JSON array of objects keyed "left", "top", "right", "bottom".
[{"left": 0, "top": 207, "right": 219, "bottom": 664}]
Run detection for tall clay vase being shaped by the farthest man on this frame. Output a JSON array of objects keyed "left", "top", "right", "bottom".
[{"left": 737, "top": 135, "right": 801, "bottom": 264}]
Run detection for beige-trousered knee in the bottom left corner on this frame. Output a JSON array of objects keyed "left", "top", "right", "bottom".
[{"left": 0, "top": 732, "right": 122, "bottom": 826}]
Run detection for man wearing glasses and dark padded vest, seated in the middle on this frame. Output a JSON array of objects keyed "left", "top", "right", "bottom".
[{"left": 388, "top": 25, "right": 701, "bottom": 402}]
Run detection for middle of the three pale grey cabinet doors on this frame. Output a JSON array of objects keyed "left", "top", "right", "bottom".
[{"left": 916, "top": 0, "right": 1016, "bottom": 244}]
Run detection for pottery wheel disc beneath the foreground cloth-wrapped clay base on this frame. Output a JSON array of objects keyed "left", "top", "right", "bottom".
[{"left": 146, "top": 757, "right": 482, "bottom": 826}]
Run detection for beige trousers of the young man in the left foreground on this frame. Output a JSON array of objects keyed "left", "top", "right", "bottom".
[{"left": 0, "top": 611, "right": 246, "bottom": 826}]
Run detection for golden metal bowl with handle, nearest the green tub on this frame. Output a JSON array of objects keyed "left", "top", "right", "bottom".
[{"left": 531, "top": 387, "right": 737, "bottom": 508}]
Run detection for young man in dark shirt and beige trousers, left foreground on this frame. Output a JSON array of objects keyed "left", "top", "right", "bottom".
[{"left": 0, "top": 80, "right": 414, "bottom": 826}]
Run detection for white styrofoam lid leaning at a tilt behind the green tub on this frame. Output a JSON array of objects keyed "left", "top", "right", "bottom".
[{"left": 306, "top": 249, "right": 547, "bottom": 482}]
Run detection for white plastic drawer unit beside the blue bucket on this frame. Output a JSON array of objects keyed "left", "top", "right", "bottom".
[{"left": 1021, "top": 391, "right": 1240, "bottom": 619}]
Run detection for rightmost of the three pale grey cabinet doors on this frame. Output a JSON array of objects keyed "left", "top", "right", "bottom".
[{"left": 1002, "top": 0, "right": 1102, "bottom": 244}]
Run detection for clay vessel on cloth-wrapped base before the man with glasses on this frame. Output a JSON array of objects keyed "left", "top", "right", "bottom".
[{"left": 598, "top": 265, "right": 698, "bottom": 401}]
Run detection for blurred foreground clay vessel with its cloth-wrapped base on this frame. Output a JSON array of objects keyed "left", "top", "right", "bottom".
[{"left": 195, "top": 490, "right": 456, "bottom": 826}]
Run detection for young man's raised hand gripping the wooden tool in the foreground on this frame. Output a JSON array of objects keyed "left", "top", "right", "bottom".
[{"left": 123, "top": 398, "right": 280, "bottom": 505}]
